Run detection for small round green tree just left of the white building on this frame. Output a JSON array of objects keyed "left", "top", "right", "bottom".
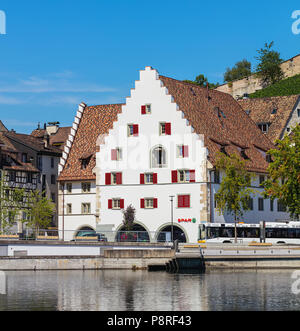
[{"left": 24, "top": 190, "right": 55, "bottom": 235}]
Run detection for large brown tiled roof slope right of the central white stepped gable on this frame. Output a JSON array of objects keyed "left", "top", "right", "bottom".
[{"left": 159, "top": 76, "right": 274, "bottom": 172}]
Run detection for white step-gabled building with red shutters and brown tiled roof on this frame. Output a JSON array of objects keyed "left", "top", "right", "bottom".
[{"left": 59, "top": 67, "right": 288, "bottom": 242}]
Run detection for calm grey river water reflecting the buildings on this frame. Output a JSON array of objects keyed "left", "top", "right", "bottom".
[{"left": 0, "top": 270, "right": 300, "bottom": 311}]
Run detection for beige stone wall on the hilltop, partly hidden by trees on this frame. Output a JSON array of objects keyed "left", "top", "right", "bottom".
[{"left": 216, "top": 54, "right": 300, "bottom": 99}]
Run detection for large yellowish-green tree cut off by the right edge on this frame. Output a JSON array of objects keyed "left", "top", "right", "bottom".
[{"left": 264, "top": 125, "right": 300, "bottom": 219}]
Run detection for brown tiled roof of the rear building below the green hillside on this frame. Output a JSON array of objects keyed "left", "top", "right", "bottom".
[{"left": 238, "top": 95, "right": 300, "bottom": 142}]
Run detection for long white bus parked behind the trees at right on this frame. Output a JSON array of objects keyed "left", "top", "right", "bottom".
[{"left": 200, "top": 222, "right": 300, "bottom": 245}]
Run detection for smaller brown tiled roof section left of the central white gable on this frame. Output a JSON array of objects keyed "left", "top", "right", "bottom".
[{"left": 59, "top": 104, "right": 122, "bottom": 181}]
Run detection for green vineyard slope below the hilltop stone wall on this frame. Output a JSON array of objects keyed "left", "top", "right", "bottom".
[{"left": 250, "top": 75, "right": 300, "bottom": 99}]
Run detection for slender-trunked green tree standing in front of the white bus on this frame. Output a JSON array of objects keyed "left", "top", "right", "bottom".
[{"left": 215, "top": 154, "right": 254, "bottom": 243}]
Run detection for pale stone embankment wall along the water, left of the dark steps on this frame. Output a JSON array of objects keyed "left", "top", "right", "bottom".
[{"left": 0, "top": 249, "right": 175, "bottom": 271}]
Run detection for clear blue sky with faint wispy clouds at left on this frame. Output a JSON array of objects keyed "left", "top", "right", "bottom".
[{"left": 0, "top": 0, "right": 300, "bottom": 133}]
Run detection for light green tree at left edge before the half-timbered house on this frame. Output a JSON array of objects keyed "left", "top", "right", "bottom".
[{"left": 0, "top": 170, "right": 25, "bottom": 233}]
